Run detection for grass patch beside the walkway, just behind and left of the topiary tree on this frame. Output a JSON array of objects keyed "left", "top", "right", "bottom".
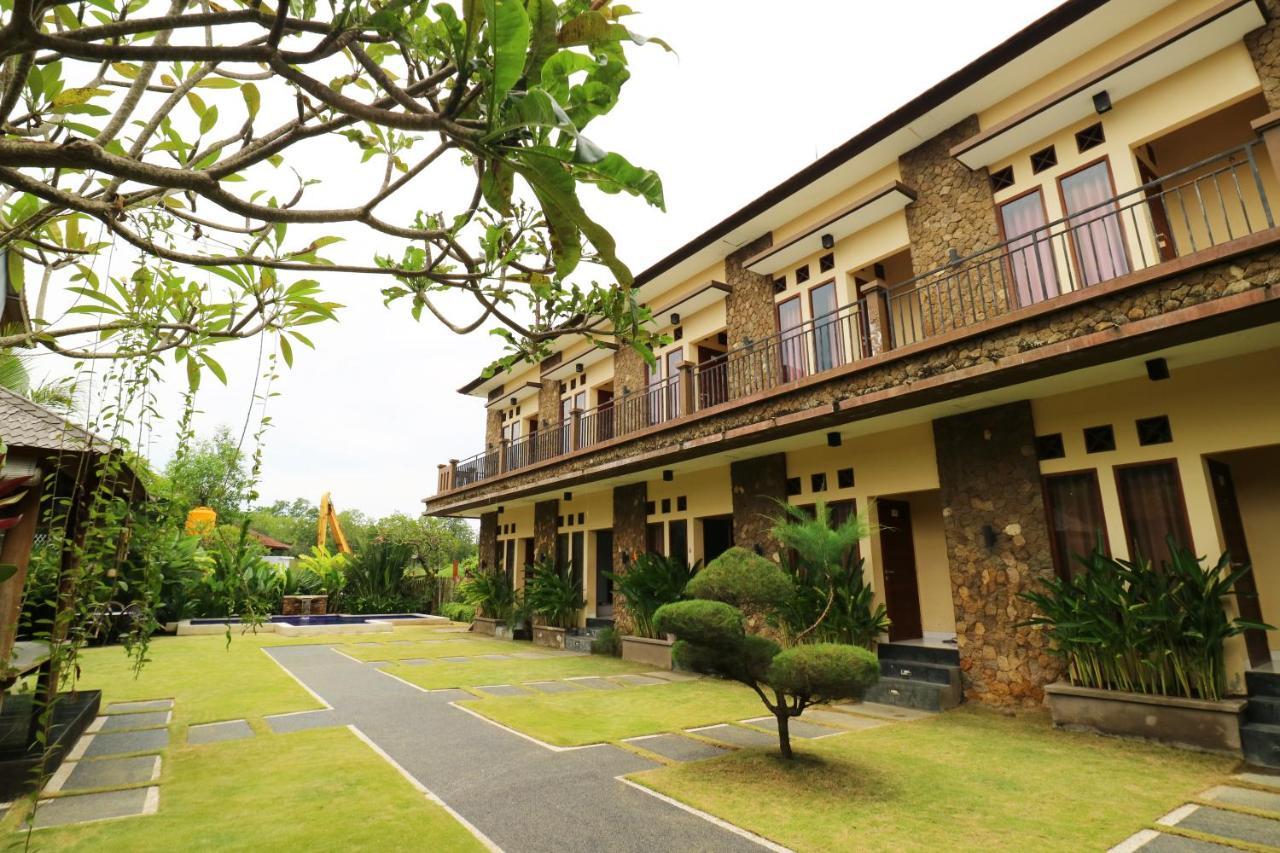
[{"left": 458, "top": 676, "right": 764, "bottom": 747}]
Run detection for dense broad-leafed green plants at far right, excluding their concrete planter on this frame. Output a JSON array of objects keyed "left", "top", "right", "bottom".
[{"left": 1021, "top": 537, "right": 1271, "bottom": 699}]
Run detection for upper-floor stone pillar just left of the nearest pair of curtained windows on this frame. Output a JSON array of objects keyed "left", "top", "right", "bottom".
[{"left": 895, "top": 115, "right": 1009, "bottom": 336}]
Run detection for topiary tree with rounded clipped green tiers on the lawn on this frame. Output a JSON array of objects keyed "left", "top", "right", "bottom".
[{"left": 654, "top": 548, "right": 879, "bottom": 758}]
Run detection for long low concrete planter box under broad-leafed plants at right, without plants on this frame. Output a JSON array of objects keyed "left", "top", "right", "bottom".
[{"left": 1044, "top": 681, "right": 1248, "bottom": 754}]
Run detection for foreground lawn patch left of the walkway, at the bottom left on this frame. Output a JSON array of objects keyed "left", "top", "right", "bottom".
[{"left": 4, "top": 729, "right": 484, "bottom": 853}]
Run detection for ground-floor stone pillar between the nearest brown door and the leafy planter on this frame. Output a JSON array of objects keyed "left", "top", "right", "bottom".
[{"left": 933, "top": 401, "right": 1059, "bottom": 707}]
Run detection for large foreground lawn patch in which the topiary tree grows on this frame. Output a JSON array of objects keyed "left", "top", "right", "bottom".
[{"left": 634, "top": 707, "right": 1236, "bottom": 850}]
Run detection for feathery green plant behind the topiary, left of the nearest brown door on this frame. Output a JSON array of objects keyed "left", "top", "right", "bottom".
[{"left": 772, "top": 502, "right": 888, "bottom": 648}]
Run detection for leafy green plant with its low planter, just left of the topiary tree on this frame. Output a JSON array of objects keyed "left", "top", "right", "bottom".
[{"left": 607, "top": 553, "right": 698, "bottom": 670}]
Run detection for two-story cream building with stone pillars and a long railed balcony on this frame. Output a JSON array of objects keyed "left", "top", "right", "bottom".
[{"left": 426, "top": 0, "right": 1280, "bottom": 704}]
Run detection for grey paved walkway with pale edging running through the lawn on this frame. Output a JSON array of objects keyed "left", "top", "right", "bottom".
[{"left": 266, "top": 646, "right": 777, "bottom": 853}]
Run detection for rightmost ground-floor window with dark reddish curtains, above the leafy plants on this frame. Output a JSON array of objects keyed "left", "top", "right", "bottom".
[{"left": 1116, "top": 461, "right": 1192, "bottom": 566}]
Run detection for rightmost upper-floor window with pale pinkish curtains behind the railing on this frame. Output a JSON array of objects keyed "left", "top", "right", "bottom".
[{"left": 1059, "top": 160, "right": 1129, "bottom": 286}]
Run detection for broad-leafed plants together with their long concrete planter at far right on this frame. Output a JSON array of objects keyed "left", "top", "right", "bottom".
[{"left": 1023, "top": 539, "right": 1270, "bottom": 752}]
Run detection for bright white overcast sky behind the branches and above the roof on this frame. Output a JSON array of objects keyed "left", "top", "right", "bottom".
[{"left": 36, "top": 0, "right": 1056, "bottom": 516}]
